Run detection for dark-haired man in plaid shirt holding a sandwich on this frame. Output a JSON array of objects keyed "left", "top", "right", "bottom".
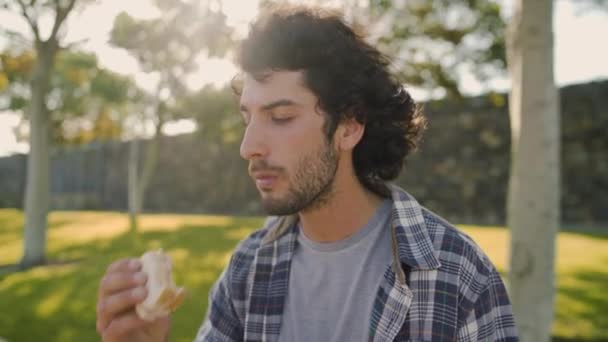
[{"left": 97, "top": 8, "right": 517, "bottom": 341}]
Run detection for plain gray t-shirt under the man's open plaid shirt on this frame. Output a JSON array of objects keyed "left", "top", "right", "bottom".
[{"left": 279, "top": 200, "right": 392, "bottom": 342}]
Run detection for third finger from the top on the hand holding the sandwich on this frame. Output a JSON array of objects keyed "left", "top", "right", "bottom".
[{"left": 97, "top": 286, "right": 147, "bottom": 332}]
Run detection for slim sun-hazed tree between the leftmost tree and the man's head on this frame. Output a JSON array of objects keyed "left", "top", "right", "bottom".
[{"left": 110, "top": 0, "right": 231, "bottom": 232}]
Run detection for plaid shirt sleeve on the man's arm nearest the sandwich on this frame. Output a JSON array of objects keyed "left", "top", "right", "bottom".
[{"left": 195, "top": 266, "right": 243, "bottom": 342}]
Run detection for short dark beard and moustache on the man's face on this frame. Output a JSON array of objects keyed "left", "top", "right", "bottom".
[{"left": 253, "top": 141, "right": 339, "bottom": 216}]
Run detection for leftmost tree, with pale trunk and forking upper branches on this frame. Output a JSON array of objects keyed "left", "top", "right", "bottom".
[{"left": 0, "top": 0, "right": 91, "bottom": 268}]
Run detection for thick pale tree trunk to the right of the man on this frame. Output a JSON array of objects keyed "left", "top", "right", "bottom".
[{"left": 507, "top": 0, "right": 560, "bottom": 342}]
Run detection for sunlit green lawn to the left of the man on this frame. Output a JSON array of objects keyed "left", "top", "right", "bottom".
[{"left": 0, "top": 219, "right": 260, "bottom": 341}]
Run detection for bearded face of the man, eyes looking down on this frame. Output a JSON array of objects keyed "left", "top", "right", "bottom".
[{"left": 240, "top": 71, "right": 338, "bottom": 215}]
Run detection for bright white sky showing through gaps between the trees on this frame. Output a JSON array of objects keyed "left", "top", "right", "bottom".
[{"left": 0, "top": 0, "right": 608, "bottom": 156}]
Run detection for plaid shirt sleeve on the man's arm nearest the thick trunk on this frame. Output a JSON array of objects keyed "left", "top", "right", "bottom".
[{"left": 457, "top": 269, "right": 519, "bottom": 342}]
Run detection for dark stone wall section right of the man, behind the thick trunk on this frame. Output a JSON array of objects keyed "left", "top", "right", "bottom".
[{"left": 399, "top": 81, "right": 608, "bottom": 224}]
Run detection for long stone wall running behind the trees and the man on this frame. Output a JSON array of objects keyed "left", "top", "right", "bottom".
[{"left": 0, "top": 81, "right": 608, "bottom": 224}]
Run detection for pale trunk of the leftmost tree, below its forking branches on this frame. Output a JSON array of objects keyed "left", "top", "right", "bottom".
[{"left": 20, "top": 41, "right": 57, "bottom": 268}]
